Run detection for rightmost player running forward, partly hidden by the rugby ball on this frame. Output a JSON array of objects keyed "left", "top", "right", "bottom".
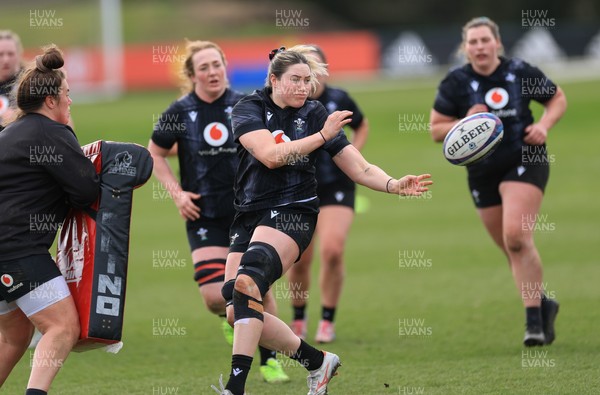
[{"left": 430, "top": 17, "right": 567, "bottom": 346}]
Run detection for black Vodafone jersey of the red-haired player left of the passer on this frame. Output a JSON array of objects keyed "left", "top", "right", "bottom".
[{"left": 152, "top": 89, "right": 245, "bottom": 218}]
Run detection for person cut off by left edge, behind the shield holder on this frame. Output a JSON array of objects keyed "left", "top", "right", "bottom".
[{"left": 0, "top": 30, "right": 23, "bottom": 130}]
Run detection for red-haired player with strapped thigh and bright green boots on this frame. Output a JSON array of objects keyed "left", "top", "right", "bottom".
[{"left": 148, "top": 41, "right": 289, "bottom": 382}]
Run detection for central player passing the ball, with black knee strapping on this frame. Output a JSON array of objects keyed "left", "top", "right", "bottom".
[{"left": 213, "top": 45, "right": 432, "bottom": 395}]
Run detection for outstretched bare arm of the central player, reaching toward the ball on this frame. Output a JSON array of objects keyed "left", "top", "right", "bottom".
[{"left": 333, "top": 145, "right": 433, "bottom": 196}]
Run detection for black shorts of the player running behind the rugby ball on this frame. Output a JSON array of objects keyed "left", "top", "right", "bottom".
[{"left": 468, "top": 155, "right": 550, "bottom": 208}]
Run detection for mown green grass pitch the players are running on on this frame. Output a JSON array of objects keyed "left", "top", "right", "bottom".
[{"left": 0, "top": 81, "right": 600, "bottom": 395}]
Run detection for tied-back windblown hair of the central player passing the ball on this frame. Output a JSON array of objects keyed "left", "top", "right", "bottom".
[{"left": 265, "top": 45, "right": 328, "bottom": 90}]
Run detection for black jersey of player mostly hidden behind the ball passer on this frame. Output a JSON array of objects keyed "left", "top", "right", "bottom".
[{"left": 316, "top": 86, "right": 363, "bottom": 187}]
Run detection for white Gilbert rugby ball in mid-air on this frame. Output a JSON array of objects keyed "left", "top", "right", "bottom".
[{"left": 444, "top": 112, "right": 504, "bottom": 166}]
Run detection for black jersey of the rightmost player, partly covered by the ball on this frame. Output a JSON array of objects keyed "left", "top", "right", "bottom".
[{"left": 433, "top": 57, "right": 557, "bottom": 172}]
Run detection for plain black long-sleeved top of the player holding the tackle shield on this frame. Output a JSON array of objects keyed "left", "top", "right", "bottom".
[{"left": 0, "top": 113, "right": 100, "bottom": 261}]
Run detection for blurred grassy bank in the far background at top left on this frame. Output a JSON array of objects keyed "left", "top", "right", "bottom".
[{"left": 0, "top": 0, "right": 314, "bottom": 49}]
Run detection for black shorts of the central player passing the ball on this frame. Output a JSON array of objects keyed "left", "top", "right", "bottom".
[{"left": 229, "top": 199, "right": 319, "bottom": 261}]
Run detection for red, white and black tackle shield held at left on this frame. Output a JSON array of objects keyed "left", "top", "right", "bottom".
[{"left": 56, "top": 141, "right": 153, "bottom": 351}]
